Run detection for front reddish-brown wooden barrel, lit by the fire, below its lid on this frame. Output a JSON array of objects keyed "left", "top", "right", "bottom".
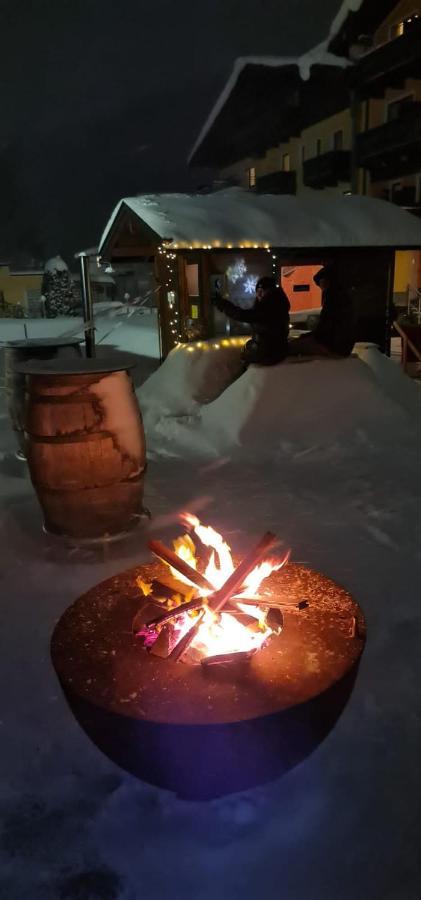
[{"left": 20, "top": 359, "right": 146, "bottom": 542}]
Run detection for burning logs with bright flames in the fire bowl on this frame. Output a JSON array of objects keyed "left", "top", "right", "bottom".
[{"left": 134, "top": 513, "right": 289, "bottom": 663}]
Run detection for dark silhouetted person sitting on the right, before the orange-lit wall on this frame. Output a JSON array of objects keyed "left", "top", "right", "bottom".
[{"left": 288, "top": 266, "right": 355, "bottom": 357}]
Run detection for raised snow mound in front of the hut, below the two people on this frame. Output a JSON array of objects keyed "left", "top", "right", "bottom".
[{"left": 140, "top": 348, "right": 421, "bottom": 462}]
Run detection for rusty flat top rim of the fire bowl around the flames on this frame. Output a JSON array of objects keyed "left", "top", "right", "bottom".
[{"left": 52, "top": 561, "right": 365, "bottom": 724}]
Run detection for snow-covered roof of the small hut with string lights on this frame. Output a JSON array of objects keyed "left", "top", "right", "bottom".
[{"left": 99, "top": 188, "right": 421, "bottom": 253}]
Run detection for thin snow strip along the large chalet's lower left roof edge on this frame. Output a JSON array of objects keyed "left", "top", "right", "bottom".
[{"left": 187, "top": 48, "right": 352, "bottom": 163}]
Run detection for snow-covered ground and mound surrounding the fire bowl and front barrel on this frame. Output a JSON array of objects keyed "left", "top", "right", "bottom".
[{"left": 0, "top": 348, "right": 421, "bottom": 900}]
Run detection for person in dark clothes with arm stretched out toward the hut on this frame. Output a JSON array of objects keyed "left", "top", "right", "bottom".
[{"left": 214, "top": 277, "right": 289, "bottom": 366}]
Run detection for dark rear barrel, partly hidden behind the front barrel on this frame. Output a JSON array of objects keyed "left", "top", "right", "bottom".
[{"left": 4, "top": 338, "right": 82, "bottom": 459}]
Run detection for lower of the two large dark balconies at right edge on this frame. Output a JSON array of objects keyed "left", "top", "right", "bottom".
[{"left": 357, "top": 102, "right": 421, "bottom": 181}]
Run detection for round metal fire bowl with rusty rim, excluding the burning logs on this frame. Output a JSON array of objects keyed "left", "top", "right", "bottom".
[{"left": 51, "top": 562, "right": 365, "bottom": 800}]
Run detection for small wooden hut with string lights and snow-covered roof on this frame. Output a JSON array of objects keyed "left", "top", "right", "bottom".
[{"left": 98, "top": 187, "right": 421, "bottom": 357}]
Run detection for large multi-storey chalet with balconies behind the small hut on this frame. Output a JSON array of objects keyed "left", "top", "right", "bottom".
[{"left": 190, "top": 0, "right": 421, "bottom": 304}]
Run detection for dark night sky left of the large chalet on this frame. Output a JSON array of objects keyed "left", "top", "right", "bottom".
[{"left": 0, "top": 0, "right": 340, "bottom": 259}]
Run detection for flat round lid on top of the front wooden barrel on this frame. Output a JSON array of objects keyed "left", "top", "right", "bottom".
[{"left": 14, "top": 352, "right": 139, "bottom": 375}]
